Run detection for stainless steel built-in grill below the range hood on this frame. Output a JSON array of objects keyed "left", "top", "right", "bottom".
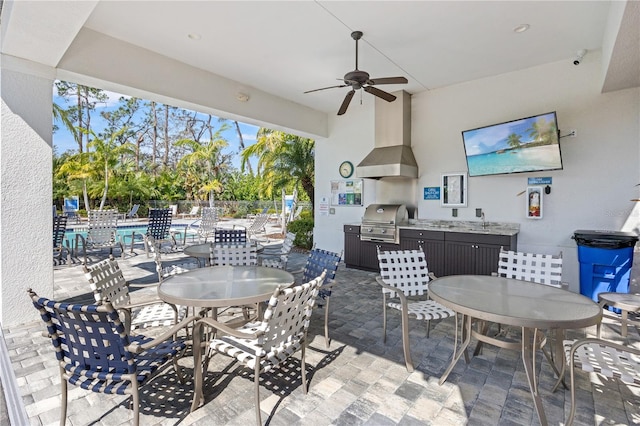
[{"left": 360, "top": 204, "right": 408, "bottom": 244}]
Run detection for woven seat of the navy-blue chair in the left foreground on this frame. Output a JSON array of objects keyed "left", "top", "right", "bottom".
[{"left": 64, "top": 335, "right": 187, "bottom": 395}]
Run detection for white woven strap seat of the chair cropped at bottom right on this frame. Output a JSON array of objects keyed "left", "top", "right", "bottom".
[{"left": 563, "top": 340, "right": 640, "bottom": 385}]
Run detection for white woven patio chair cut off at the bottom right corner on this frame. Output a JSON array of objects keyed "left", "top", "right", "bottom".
[{"left": 553, "top": 338, "right": 640, "bottom": 425}]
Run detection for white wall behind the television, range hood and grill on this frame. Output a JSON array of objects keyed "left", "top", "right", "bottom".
[{"left": 315, "top": 52, "right": 640, "bottom": 291}]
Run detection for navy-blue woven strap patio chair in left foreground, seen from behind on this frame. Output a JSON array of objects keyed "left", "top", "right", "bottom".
[{"left": 28, "top": 289, "right": 197, "bottom": 426}]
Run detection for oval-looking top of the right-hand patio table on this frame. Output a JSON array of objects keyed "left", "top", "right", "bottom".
[{"left": 429, "top": 275, "right": 602, "bottom": 329}]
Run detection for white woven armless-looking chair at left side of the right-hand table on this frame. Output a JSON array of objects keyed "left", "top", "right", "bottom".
[{"left": 376, "top": 247, "right": 458, "bottom": 372}]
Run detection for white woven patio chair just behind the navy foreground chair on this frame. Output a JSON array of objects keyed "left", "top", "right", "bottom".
[{"left": 84, "top": 257, "right": 185, "bottom": 334}]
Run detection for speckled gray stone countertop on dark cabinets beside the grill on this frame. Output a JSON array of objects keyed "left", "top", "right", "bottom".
[{"left": 346, "top": 219, "right": 520, "bottom": 236}]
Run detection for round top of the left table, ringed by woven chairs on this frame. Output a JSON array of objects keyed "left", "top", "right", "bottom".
[{"left": 158, "top": 266, "right": 295, "bottom": 308}]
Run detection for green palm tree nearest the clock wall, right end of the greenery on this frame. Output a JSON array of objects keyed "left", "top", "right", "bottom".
[{"left": 241, "top": 128, "right": 315, "bottom": 210}]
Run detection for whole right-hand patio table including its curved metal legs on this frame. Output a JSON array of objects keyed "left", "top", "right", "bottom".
[{"left": 429, "top": 275, "right": 602, "bottom": 425}]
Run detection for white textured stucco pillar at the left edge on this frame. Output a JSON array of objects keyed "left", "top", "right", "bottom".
[{"left": 0, "top": 63, "right": 53, "bottom": 327}]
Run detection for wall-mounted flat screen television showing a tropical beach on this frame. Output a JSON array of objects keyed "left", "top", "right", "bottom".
[{"left": 462, "top": 111, "right": 562, "bottom": 176}]
